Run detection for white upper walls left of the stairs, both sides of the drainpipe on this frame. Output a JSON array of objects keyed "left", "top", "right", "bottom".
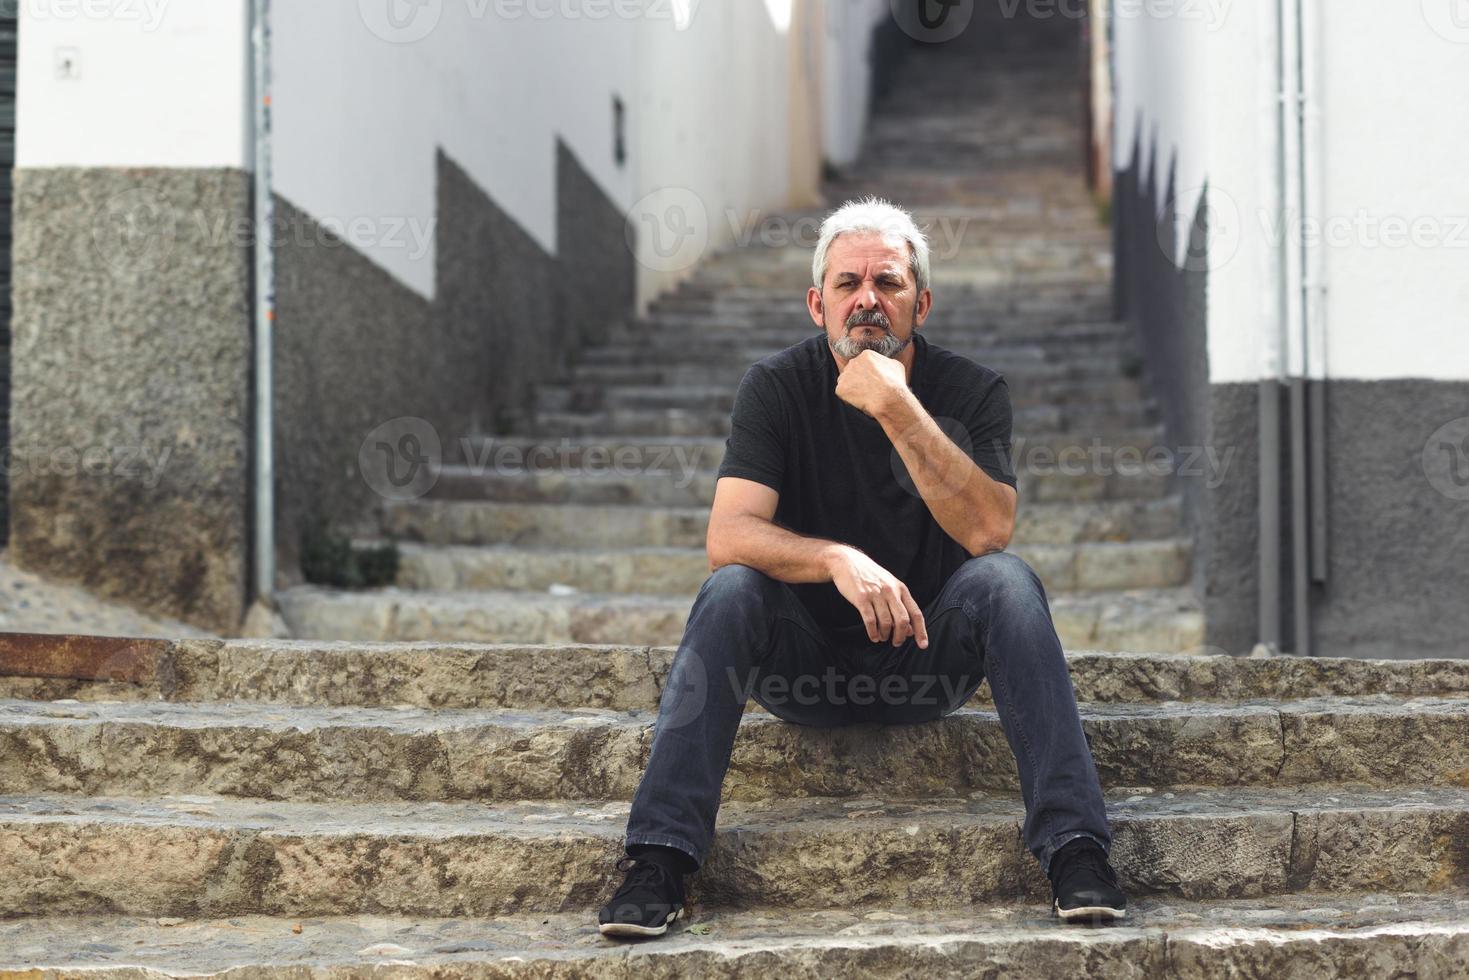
[{"left": 19, "top": 0, "right": 886, "bottom": 301}]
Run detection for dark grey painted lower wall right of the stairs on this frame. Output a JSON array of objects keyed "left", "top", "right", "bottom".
[{"left": 1112, "top": 126, "right": 1469, "bottom": 660}]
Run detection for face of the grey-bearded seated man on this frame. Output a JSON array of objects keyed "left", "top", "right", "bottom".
[{"left": 806, "top": 232, "right": 933, "bottom": 360}]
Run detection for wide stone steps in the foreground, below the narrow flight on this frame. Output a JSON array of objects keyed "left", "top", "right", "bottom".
[{"left": 0, "top": 639, "right": 1469, "bottom": 977}]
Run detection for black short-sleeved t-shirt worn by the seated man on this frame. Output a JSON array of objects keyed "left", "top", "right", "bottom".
[{"left": 718, "top": 331, "right": 1015, "bottom": 645}]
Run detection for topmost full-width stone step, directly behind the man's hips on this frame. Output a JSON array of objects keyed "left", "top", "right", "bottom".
[{"left": 11, "top": 639, "right": 1469, "bottom": 711}]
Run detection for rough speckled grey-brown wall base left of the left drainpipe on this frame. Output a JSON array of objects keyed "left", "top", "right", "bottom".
[{"left": 9, "top": 169, "right": 251, "bottom": 629}]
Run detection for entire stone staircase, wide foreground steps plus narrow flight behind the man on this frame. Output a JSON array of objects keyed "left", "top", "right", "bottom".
[{"left": 0, "top": 9, "right": 1469, "bottom": 980}]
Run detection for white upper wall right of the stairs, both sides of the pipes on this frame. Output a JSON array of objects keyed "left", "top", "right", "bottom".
[{"left": 1114, "top": 0, "right": 1469, "bottom": 382}]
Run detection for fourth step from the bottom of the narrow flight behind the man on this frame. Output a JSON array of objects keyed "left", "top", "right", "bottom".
[{"left": 426, "top": 458, "right": 1175, "bottom": 507}]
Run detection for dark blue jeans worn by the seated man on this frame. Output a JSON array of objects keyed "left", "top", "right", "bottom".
[{"left": 626, "top": 551, "right": 1112, "bottom": 871}]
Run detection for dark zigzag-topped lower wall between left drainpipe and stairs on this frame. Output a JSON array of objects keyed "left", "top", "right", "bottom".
[{"left": 276, "top": 141, "right": 636, "bottom": 582}]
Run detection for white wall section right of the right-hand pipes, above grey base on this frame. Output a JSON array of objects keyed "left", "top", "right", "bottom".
[{"left": 1321, "top": 0, "right": 1469, "bottom": 379}]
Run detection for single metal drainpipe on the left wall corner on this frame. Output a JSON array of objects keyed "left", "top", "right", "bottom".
[{"left": 250, "top": 0, "right": 275, "bottom": 605}]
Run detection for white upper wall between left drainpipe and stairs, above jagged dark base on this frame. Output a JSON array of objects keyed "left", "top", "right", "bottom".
[{"left": 273, "top": 0, "right": 840, "bottom": 303}]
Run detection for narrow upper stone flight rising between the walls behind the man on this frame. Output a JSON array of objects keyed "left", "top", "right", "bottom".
[{"left": 281, "top": 51, "right": 1203, "bottom": 651}]
